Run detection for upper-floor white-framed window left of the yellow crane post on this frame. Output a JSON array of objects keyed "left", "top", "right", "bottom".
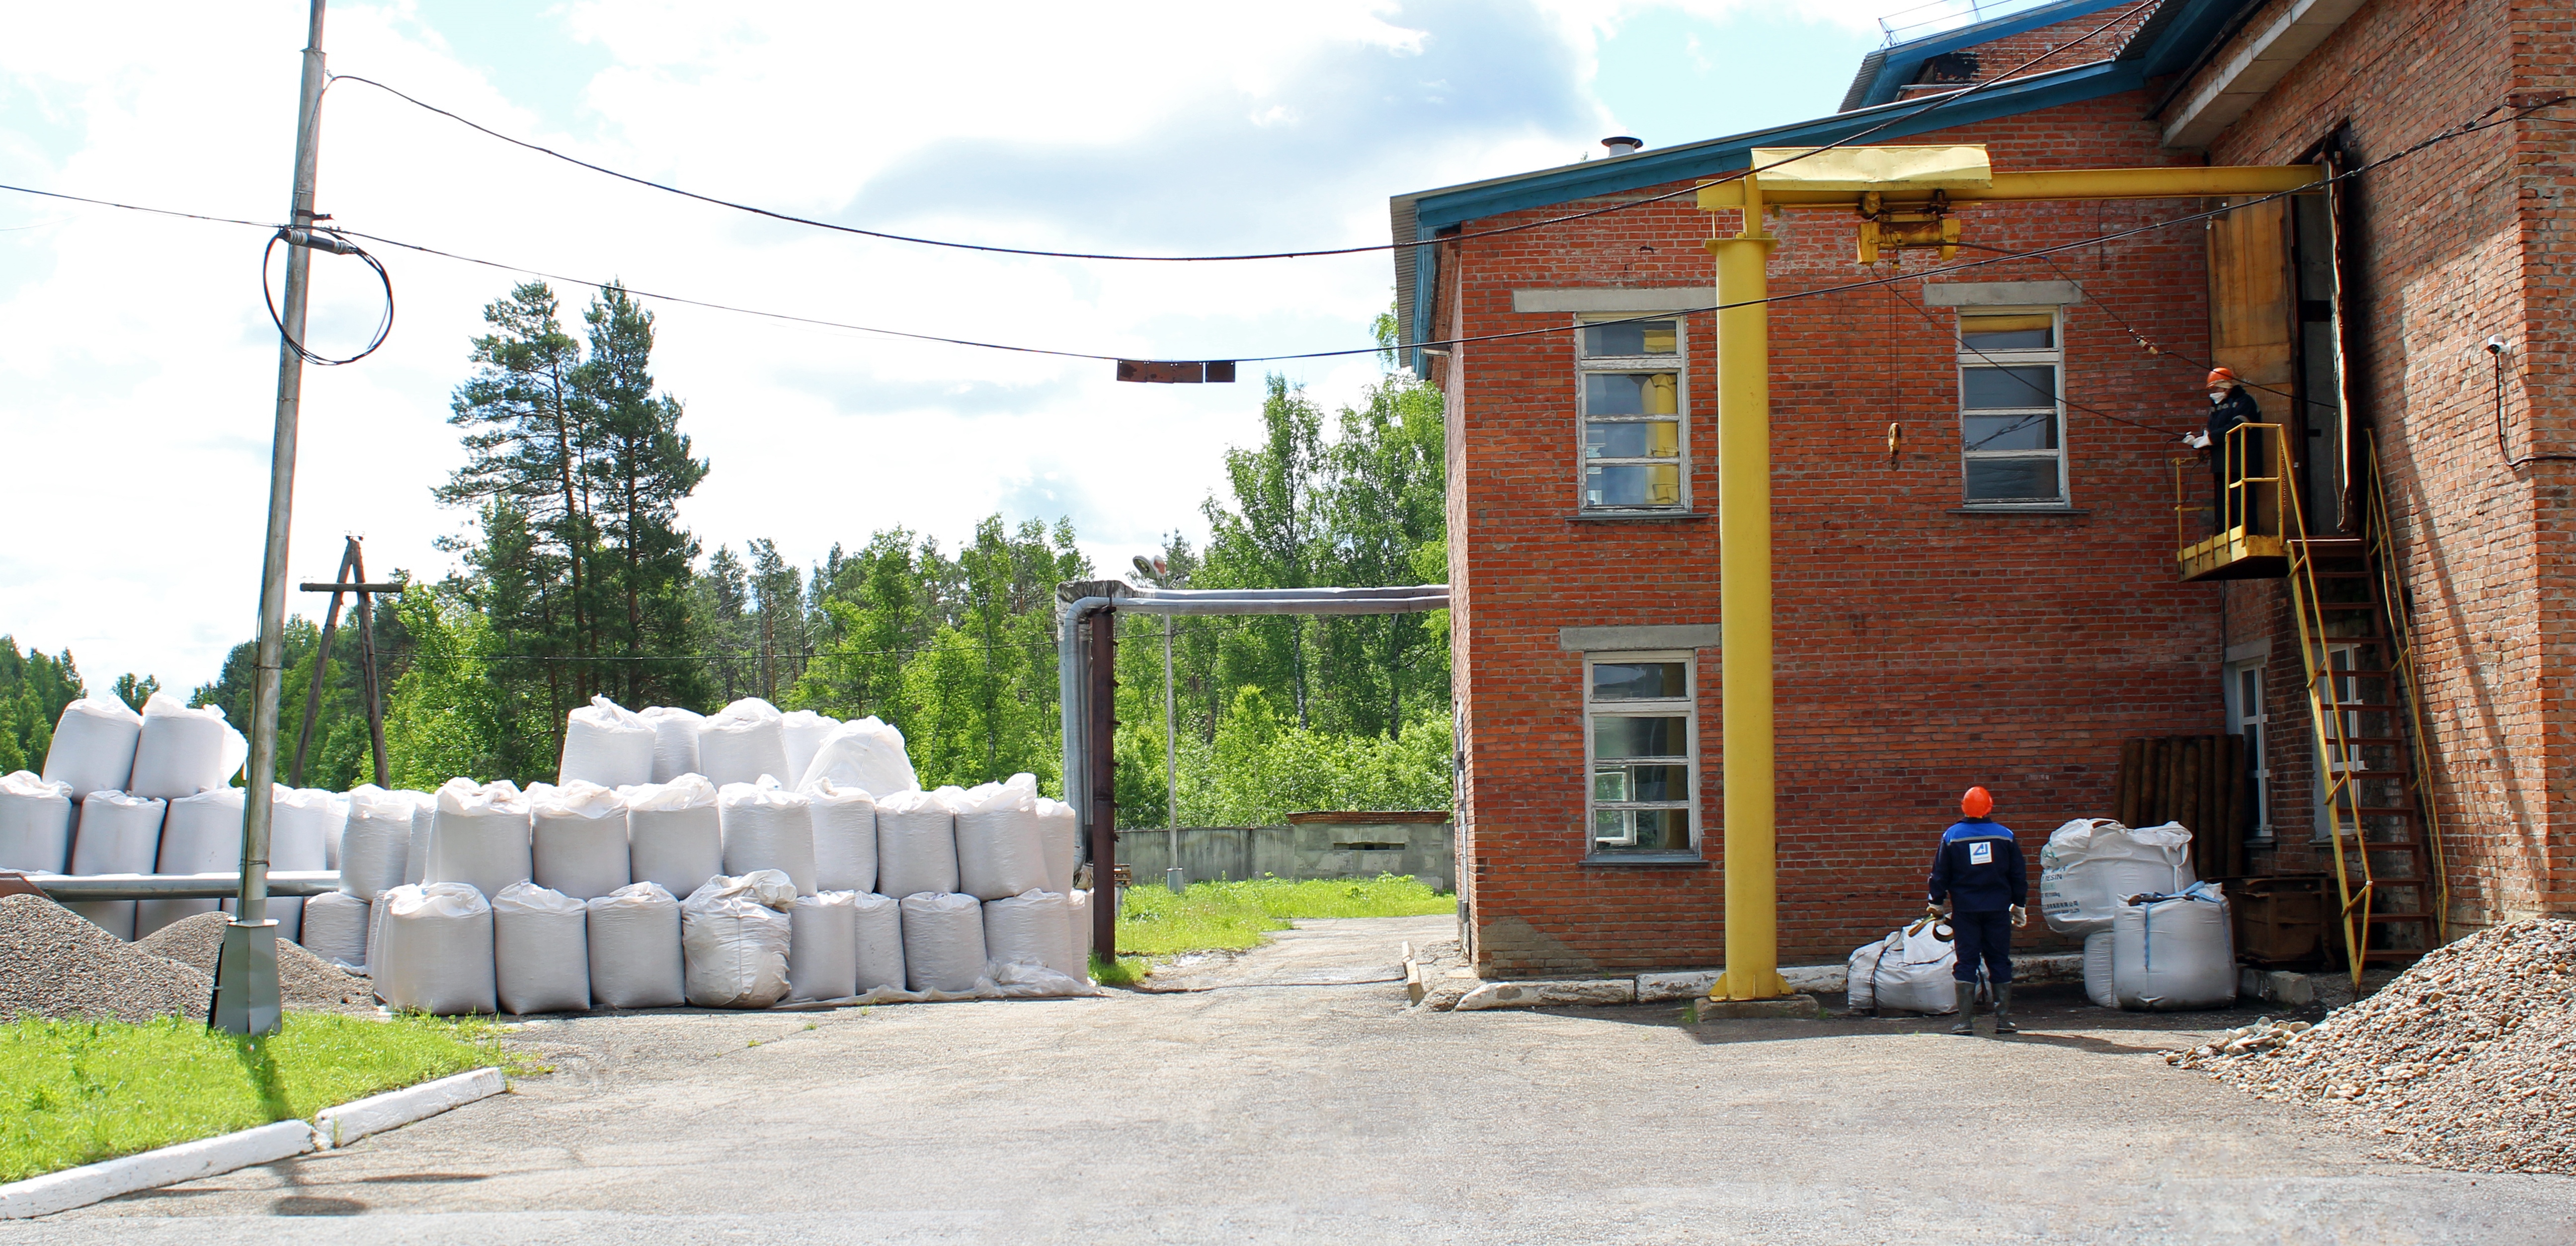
[{"left": 1574, "top": 316, "right": 1690, "bottom": 510}]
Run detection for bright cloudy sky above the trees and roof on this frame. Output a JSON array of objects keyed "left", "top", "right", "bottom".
[{"left": 0, "top": 0, "right": 1906, "bottom": 690}]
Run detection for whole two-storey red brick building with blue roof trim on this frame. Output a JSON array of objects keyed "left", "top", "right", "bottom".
[{"left": 1391, "top": 0, "right": 2576, "bottom": 976}]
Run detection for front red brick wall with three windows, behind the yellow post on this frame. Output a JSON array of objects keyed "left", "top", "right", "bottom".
[{"left": 1440, "top": 93, "right": 2221, "bottom": 973}]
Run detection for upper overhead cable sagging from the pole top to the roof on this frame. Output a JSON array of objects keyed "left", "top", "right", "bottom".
[{"left": 324, "top": 0, "right": 2161, "bottom": 263}]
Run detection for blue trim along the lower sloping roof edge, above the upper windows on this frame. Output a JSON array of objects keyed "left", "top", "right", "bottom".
[{"left": 1412, "top": 62, "right": 2146, "bottom": 355}]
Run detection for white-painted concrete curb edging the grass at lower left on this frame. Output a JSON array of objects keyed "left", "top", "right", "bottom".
[{"left": 0, "top": 1068, "right": 510, "bottom": 1220}]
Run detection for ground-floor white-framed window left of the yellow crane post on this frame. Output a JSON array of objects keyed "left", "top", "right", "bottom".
[{"left": 1584, "top": 649, "right": 1700, "bottom": 855}]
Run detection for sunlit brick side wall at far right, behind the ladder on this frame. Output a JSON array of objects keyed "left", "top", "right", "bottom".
[{"left": 2202, "top": 0, "right": 2576, "bottom": 930}]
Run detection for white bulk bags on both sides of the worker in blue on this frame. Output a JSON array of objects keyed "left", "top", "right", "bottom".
[{"left": 1845, "top": 819, "right": 2236, "bottom": 1012}]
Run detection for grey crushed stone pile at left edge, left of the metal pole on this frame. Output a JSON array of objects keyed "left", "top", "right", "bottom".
[{"left": 0, "top": 896, "right": 214, "bottom": 1022}]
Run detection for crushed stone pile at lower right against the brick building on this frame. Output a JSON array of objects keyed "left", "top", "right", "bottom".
[{"left": 2167, "top": 919, "right": 2576, "bottom": 1174}]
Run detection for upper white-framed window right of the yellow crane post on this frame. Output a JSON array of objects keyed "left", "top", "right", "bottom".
[{"left": 1958, "top": 307, "right": 2066, "bottom": 507}]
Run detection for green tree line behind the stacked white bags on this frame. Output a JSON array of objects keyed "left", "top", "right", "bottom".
[{"left": 193, "top": 283, "right": 1450, "bottom": 826}]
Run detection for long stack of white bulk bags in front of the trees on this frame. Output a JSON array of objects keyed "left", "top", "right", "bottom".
[{"left": 0, "top": 698, "right": 1095, "bottom": 1014}]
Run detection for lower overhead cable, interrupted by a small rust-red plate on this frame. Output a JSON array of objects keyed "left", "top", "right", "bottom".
[{"left": 0, "top": 94, "right": 2548, "bottom": 363}]
